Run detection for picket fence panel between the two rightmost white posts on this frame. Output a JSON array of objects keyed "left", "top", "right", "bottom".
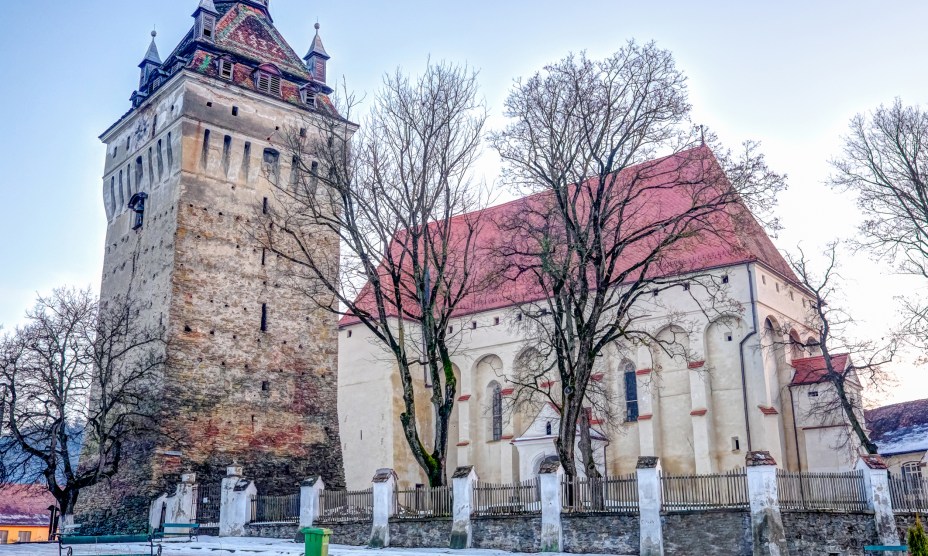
[{"left": 777, "top": 470, "right": 867, "bottom": 512}]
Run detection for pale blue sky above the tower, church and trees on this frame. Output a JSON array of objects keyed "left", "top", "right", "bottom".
[{"left": 0, "top": 0, "right": 928, "bottom": 403}]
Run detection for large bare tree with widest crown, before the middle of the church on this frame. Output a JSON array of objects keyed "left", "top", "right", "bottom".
[{"left": 493, "top": 42, "right": 785, "bottom": 476}]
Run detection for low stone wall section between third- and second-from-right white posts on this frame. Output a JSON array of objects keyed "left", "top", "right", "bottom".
[{"left": 661, "top": 510, "right": 752, "bottom": 556}]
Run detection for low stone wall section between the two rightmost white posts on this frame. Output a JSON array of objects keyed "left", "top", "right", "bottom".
[{"left": 783, "top": 511, "right": 879, "bottom": 556}]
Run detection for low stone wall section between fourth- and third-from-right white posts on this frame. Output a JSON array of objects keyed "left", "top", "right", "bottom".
[{"left": 561, "top": 514, "right": 638, "bottom": 554}]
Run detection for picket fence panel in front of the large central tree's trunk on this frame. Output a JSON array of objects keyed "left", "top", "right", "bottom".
[{"left": 561, "top": 473, "right": 638, "bottom": 512}]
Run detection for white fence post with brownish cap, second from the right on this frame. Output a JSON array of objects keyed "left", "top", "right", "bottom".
[{"left": 745, "top": 451, "right": 789, "bottom": 556}]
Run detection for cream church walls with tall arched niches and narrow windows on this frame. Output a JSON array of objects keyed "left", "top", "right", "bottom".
[{"left": 339, "top": 151, "right": 858, "bottom": 488}]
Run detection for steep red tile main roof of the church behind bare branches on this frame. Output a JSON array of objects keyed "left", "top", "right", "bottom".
[{"left": 340, "top": 147, "right": 798, "bottom": 326}]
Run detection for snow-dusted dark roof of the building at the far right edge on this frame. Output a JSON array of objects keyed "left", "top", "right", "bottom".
[{"left": 865, "top": 398, "right": 928, "bottom": 456}]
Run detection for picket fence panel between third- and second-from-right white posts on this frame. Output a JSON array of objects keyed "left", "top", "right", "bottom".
[{"left": 661, "top": 468, "right": 750, "bottom": 510}]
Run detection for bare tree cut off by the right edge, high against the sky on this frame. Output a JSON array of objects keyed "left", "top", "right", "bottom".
[{"left": 831, "top": 99, "right": 928, "bottom": 349}]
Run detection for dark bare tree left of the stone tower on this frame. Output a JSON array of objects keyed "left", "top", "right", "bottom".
[{"left": 0, "top": 289, "right": 164, "bottom": 524}]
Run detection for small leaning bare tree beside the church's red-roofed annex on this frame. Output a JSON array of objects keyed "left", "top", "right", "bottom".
[{"left": 776, "top": 242, "right": 898, "bottom": 454}]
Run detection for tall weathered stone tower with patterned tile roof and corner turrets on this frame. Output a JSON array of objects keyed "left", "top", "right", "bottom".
[{"left": 78, "top": 0, "right": 344, "bottom": 529}]
